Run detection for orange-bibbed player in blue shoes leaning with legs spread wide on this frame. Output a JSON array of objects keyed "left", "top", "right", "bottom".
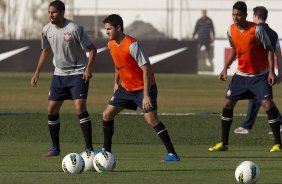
[{"left": 98, "top": 14, "right": 180, "bottom": 162}]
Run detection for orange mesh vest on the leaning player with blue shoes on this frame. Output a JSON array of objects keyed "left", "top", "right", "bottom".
[{"left": 108, "top": 36, "right": 155, "bottom": 91}]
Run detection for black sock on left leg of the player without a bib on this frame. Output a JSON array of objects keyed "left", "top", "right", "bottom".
[{"left": 48, "top": 114, "right": 60, "bottom": 151}]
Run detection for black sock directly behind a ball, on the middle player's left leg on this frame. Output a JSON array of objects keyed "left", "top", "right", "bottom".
[{"left": 103, "top": 120, "right": 114, "bottom": 152}]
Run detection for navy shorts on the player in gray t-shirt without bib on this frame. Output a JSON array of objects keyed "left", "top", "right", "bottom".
[{"left": 48, "top": 74, "right": 89, "bottom": 101}]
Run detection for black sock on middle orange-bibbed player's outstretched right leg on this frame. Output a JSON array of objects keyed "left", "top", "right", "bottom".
[{"left": 154, "top": 122, "right": 177, "bottom": 155}]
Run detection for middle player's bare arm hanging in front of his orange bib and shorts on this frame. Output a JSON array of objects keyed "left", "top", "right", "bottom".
[{"left": 141, "top": 63, "right": 152, "bottom": 111}]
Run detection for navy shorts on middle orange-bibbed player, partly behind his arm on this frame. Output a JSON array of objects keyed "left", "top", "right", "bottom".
[{"left": 109, "top": 85, "right": 158, "bottom": 113}]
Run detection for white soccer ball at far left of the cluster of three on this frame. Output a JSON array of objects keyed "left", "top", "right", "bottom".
[{"left": 62, "top": 153, "right": 84, "bottom": 174}]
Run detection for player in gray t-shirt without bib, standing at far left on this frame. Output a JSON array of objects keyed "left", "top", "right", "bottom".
[{"left": 31, "top": 0, "right": 97, "bottom": 156}]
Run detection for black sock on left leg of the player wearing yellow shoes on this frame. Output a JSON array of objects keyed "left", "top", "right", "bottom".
[{"left": 221, "top": 108, "right": 233, "bottom": 145}]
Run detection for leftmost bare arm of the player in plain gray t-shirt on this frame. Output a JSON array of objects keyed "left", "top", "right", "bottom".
[{"left": 30, "top": 48, "right": 51, "bottom": 87}]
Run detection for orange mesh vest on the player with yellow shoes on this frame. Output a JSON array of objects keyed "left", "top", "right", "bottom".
[{"left": 230, "top": 22, "right": 268, "bottom": 74}]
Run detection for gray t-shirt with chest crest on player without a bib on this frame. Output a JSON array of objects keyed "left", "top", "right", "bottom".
[{"left": 41, "top": 19, "right": 92, "bottom": 75}]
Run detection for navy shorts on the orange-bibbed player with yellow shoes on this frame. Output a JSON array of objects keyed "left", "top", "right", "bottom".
[{"left": 225, "top": 73, "right": 273, "bottom": 101}]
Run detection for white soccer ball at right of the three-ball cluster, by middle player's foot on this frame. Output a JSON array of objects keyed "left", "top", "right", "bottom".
[{"left": 93, "top": 151, "right": 116, "bottom": 172}]
